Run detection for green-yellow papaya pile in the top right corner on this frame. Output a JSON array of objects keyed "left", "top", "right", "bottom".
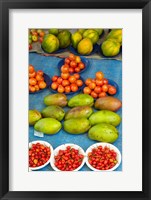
[{"left": 101, "top": 29, "right": 122, "bottom": 57}]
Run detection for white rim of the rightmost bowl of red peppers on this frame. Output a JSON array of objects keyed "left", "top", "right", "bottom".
[{"left": 86, "top": 142, "right": 121, "bottom": 172}]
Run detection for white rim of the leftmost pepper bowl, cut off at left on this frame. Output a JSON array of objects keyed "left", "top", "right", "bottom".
[{"left": 29, "top": 140, "right": 53, "bottom": 171}]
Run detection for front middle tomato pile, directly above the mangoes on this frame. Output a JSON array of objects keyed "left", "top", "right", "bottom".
[{"left": 51, "top": 73, "right": 83, "bottom": 93}]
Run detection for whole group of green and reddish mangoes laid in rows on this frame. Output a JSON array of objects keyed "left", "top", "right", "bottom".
[{"left": 29, "top": 93, "right": 121, "bottom": 143}]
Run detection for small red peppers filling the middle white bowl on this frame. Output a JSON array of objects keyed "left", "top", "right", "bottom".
[{"left": 54, "top": 146, "right": 84, "bottom": 171}]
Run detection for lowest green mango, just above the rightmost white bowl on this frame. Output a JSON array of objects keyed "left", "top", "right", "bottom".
[{"left": 88, "top": 123, "right": 119, "bottom": 143}]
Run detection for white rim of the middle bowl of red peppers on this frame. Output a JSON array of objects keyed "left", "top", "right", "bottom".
[{"left": 50, "top": 143, "right": 86, "bottom": 172}]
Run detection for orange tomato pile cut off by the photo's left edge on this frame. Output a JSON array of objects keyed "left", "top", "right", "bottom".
[{"left": 29, "top": 65, "right": 47, "bottom": 92}]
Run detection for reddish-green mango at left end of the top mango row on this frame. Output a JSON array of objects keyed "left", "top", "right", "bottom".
[{"left": 44, "top": 93, "right": 68, "bottom": 107}]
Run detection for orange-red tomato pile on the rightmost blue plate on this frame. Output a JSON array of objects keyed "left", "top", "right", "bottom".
[{"left": 83, "top": 72, "right": 117, "bottom": 98}]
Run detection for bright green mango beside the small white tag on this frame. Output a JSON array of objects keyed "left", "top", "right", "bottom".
[{"left": 34, "top": 118, "right": 62, "bottom": 135}]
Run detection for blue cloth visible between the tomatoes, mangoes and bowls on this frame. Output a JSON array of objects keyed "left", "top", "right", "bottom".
[{"left": 29, "top": 53, "right": 122, "bottom": 171}]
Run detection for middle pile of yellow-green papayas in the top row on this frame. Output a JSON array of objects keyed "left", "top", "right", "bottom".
[{"left": 71, "top": 29, "right": 103, "bottom": 55}]
